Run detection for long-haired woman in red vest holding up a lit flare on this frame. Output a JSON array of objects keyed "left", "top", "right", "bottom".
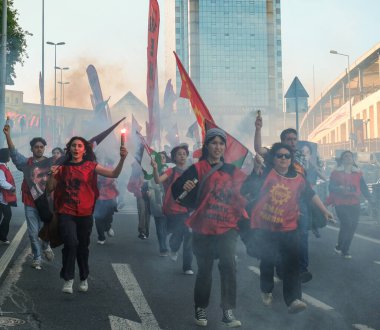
[{"left": 47, "top": 136, "right": 128, "bottom": 293}]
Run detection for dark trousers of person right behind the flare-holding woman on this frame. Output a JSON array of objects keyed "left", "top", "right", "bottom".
[{"left": 94, "top": 199, "right": 116, "bottom": 241}]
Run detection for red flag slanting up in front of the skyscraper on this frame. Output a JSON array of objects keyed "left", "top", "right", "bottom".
[{"left": 174, "top": 52, "right": 215, "bottom": 138}]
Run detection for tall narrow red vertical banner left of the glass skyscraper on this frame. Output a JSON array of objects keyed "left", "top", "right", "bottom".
[{"left": 146, "top": 0, "right": 160, "bottom": 143}]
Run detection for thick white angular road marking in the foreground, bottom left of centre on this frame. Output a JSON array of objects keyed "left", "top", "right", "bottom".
[{"left": 109, "top": 264, "right": 160, "bottom": 330}]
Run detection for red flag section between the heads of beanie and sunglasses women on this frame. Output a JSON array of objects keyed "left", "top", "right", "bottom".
[{"left": 205, "top": 119, "right": 250, "bottom": 168}]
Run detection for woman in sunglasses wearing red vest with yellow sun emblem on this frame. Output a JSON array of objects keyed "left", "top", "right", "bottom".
[{"left": 242, "top": 143, "right": 332, "bottom": 313}]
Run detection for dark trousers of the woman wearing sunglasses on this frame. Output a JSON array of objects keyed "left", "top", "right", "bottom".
[{"left": 256, "top": 230, "right": 302, "bottom": 306}]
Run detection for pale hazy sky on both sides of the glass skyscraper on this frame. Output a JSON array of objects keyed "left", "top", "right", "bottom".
[{"left": 7, "top": 0, "right": 380, "bottom": 108}]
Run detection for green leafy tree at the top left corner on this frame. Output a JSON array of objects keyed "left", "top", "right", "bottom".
[{"left": 0, "top": 0, "right": 32, "bottom": 85}]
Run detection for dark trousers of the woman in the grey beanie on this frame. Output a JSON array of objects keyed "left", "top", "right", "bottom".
[{"left": 193, "top": 229, "right": 238, "bottom": 309}]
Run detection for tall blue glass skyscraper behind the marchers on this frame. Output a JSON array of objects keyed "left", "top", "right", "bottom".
[{"left": 166, "top": 0, "right": 282, "bottom": 141}]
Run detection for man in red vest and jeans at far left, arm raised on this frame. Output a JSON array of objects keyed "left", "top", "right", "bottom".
[{"left": 3, "top": 125, "right": 54, "bottom": 270}]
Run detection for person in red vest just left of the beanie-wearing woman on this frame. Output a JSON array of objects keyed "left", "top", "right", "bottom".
[{"left": 152, "top": 143, "right": 194, "bottom": 275}]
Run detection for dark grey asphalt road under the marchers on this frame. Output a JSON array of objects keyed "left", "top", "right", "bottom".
[{"left": 0, "top": 208, "right": 380, "bottom": 330}]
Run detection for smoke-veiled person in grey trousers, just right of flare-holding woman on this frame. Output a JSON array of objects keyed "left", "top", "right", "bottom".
[{"left": 127, "top": 161, "right": 150, "bottom": 240}]
